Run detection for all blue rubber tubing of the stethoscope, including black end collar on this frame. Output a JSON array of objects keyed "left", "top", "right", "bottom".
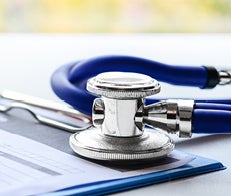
[{"left": 51, "top": 55, "right": 231, "bottom": 134}]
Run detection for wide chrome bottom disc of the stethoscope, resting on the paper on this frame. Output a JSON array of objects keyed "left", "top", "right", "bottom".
[{"left": 69, "top": 128, "right": 174, "bottom": 161}]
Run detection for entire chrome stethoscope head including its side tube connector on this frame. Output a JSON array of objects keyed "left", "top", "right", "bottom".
[{"left": 70, "top": 72, "right": 194, "bottom": 160}]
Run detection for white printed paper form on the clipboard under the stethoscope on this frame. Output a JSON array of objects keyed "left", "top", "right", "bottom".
[{"left": 0, "top": 130, "right": 193, "bottom": 195}]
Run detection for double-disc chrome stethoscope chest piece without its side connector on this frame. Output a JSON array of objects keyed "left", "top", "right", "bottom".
[{"left": 70, "top": 72, "right": 174, "bottom": 161}]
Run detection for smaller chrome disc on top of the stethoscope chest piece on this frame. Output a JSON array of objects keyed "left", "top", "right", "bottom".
[{"left": 87, "top": 72, "right": 160, "bottom": 99}]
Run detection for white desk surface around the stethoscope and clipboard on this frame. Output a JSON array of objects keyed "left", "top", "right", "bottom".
[{"left": 0, "top": 34, "right": 231, "bottom": 196}]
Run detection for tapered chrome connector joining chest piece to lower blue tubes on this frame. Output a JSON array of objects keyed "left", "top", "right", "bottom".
[{"left": 135, "top": 100, "right": 194, "bottom": 138}]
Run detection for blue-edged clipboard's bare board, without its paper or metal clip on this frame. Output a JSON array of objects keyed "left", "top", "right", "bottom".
[{"left": 0, "top": 103, "right": 225, "bottom": 196}]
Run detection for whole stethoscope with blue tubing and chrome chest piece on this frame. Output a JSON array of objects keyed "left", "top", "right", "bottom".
[{"left": 51, "top": 56, "right": 231, "bottom": 161}]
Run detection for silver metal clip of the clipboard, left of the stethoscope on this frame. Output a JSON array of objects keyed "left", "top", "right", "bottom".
[{"left": 0, "top": 90, "right": 92, "bottom": 133}]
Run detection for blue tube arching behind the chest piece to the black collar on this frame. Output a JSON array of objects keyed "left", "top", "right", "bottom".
[{"left": 68, "top": 56, "right": 208, "bottom": 88}]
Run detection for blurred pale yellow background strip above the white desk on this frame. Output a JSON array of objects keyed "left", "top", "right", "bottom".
[{"left": 0, "top": 0, "right": 231, "bottom": 33}]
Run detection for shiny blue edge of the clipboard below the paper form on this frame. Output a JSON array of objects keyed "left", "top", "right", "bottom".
[{"left": 43, "top": 156, "right": 226, "bottom": 196}]
